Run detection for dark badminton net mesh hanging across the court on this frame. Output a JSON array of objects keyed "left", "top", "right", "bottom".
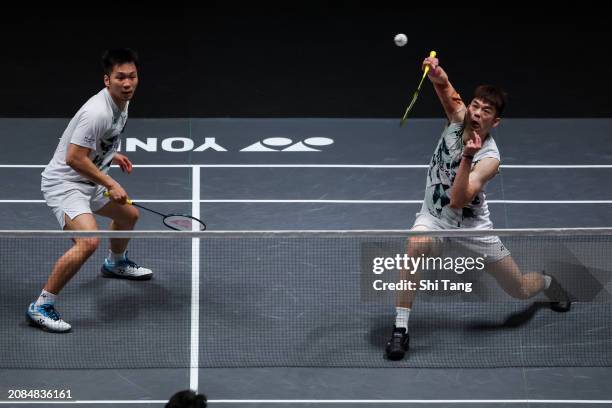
[{"left": 0, "top": 231, "right": 612, "bottom": 368}]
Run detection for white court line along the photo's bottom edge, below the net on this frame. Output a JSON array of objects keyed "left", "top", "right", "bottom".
[{"left": 0, "top": 399, "right": 612, "bottom": 405}]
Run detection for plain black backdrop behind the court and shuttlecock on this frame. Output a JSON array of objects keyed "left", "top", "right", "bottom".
[{"left": 0, "top": 1, "right": 612, "bottom": 117}]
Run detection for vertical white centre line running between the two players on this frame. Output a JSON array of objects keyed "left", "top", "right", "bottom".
[{"left": 189, "top": 167, "right": 200, "bottom": 392}]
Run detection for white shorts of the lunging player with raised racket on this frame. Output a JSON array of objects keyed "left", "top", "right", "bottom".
[{"left": 412, "top": 212, "right": 510, "bottom": 263}]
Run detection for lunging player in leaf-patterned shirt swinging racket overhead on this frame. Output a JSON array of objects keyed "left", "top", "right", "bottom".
[{"left": 385, "top": 58, "right": 571, "bottom": 360}]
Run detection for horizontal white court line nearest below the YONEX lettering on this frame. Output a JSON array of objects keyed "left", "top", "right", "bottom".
[{"left": 0, "top": 164, "right": 612, "bottom": 169}]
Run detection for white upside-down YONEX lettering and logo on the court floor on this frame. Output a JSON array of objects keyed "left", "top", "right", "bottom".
[{"left": 125, "top": 137, "right": 334, "bottom": 152}]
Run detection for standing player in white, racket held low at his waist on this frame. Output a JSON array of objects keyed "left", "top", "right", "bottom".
[{"left": 27, "top": 49, "right": 152, "bottom": 332}]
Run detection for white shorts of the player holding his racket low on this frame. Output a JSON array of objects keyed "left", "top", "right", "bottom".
[{"left": 40, "top": 178, "right": 109, "bottom": 229}]
